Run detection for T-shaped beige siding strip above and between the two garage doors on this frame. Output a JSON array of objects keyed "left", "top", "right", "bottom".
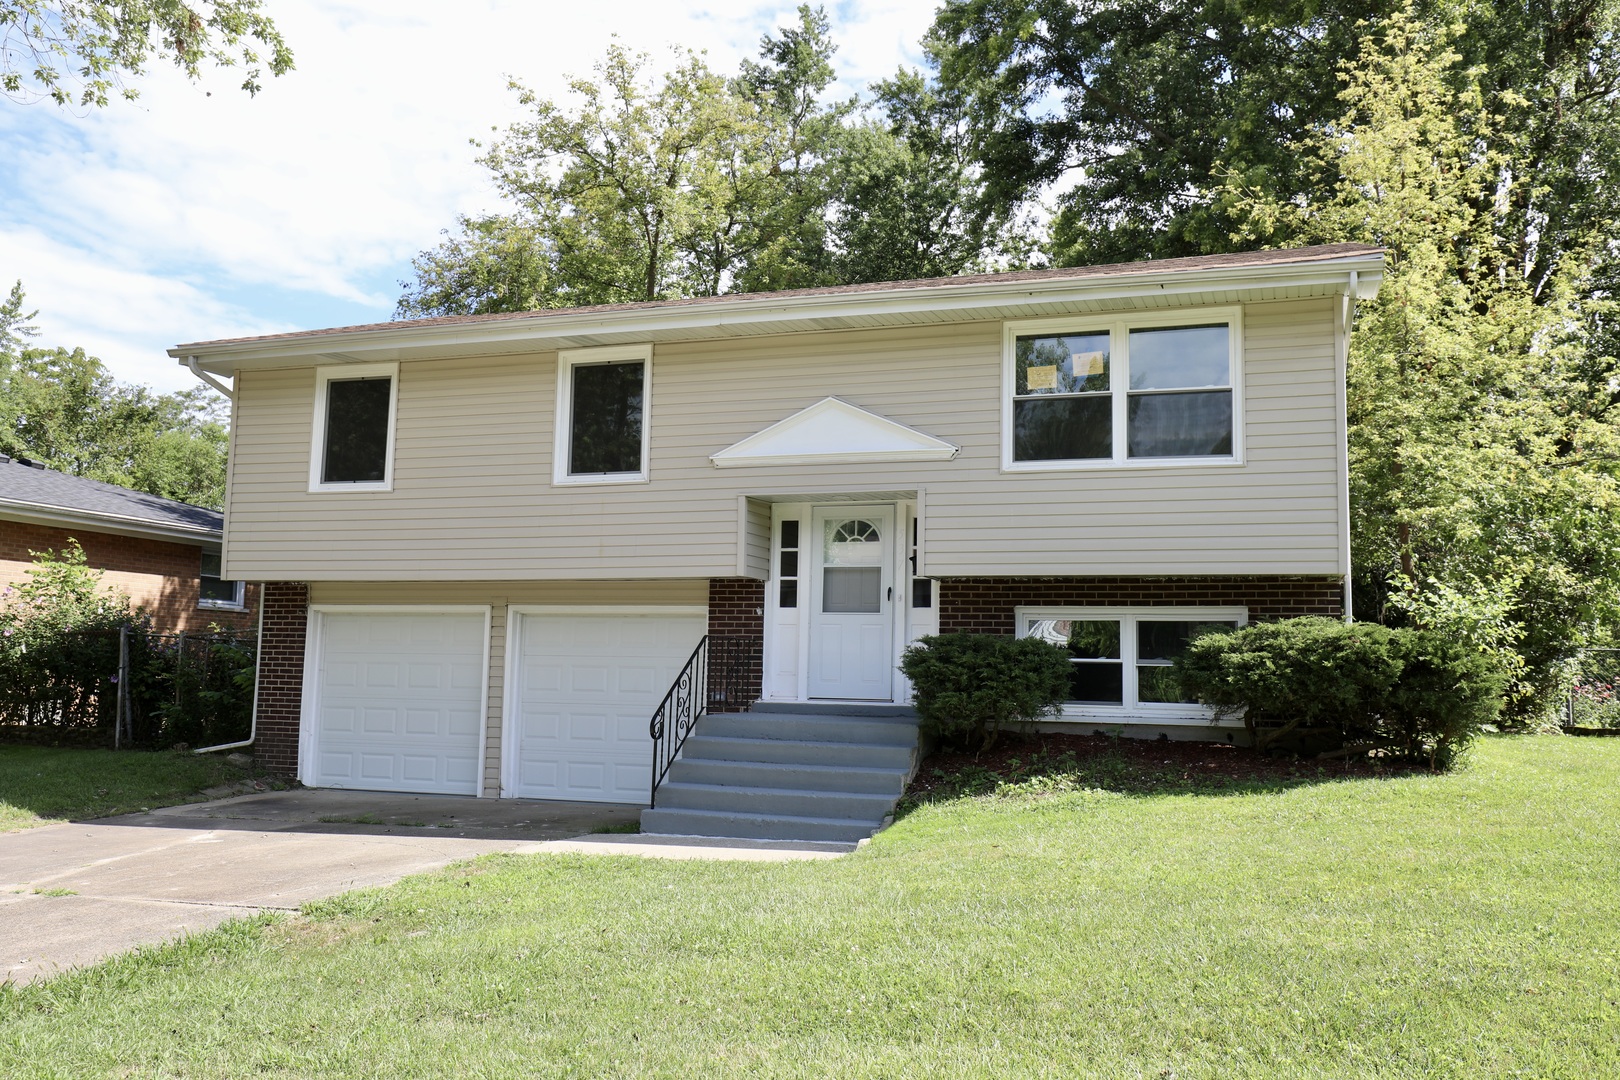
[{"left": 309, "top": 578, "right": 708, "bottom": 798}]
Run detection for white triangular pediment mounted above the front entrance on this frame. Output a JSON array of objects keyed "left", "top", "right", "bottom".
[{"left": 710, "top": 397, "right": 961, "bottom": 468}]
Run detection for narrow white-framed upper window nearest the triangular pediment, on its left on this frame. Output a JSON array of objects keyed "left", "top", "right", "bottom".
[{"left": 552, "top": 345, "right": 653, "bottom": 484}]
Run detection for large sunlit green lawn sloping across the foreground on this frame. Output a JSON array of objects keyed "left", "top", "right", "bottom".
[{"left": 0, "top": 737, "right": 1620, "bottom": 1080}]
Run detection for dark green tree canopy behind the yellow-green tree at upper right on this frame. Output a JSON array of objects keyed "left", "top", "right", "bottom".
[{"left": 933, "top": 0, "right": 1620, "bottom": 280}]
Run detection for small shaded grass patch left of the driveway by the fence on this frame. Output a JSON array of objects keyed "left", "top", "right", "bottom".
[{"left": 0, "top": 745, "right": 248, "bottom": 832}]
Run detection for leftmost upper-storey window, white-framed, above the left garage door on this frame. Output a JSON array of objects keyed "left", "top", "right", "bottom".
[{"left": 309, "top": 364, "right": 399, "bottom": 491}]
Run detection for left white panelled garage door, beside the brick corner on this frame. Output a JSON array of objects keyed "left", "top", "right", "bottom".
[{"left": 306, "top": 610, "right": 486, "bottom": 795}]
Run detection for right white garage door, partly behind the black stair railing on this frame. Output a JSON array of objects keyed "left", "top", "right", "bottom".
[{"left": 507, "top": 612, "right": 705, "bottom": 803}]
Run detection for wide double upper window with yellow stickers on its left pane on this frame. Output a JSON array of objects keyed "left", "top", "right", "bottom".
[{"left": 1003, "top": 308, "right": 1243, "bottom": 470}]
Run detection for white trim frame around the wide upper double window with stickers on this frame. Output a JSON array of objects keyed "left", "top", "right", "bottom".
[{"left": 1001, "top": 304, "right": 1244, "bottom": 473}]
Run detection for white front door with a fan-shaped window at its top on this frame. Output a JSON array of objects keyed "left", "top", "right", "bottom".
[{"left": 810, "top": 504, "right": 894, "bottom": 701}]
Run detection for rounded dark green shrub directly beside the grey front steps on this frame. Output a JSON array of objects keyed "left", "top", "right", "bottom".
[{"left": 901, "top": 633, "right": 1069, "bottom": 750}]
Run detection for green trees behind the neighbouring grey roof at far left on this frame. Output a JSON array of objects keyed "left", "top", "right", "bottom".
[{"left": 0, "top": 282, "right": 230, "bottom": 510}]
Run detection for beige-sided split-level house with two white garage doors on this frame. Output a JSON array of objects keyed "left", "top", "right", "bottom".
[{"left": 170, "top": 244, "right": 1382, "bottom": 835}]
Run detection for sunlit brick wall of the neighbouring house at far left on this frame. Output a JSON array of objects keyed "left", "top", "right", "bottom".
[{"left": 0, "top": 521, "right": 259, "bottom": 633}]
